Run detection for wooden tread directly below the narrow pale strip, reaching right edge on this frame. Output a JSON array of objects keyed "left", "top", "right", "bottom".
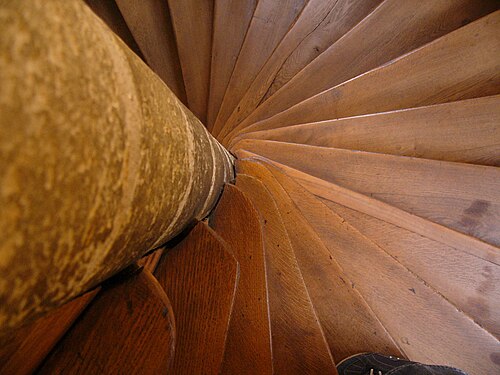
[{"left": 320, "top": 198, "right": 500, "bottom": 339}]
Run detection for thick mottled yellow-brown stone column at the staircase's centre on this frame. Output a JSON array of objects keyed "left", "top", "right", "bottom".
[{"left": 0, "top": 0, "right": 233, "bottom": 332}]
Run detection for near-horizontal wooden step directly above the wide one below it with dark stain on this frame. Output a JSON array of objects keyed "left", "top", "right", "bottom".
[{"left": 234, "top": 95, "right": 500, "bottom": 166}]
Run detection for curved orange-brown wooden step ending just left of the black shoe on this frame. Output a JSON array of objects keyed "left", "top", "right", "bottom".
[{"left": 236, "top": 174, "right": 336, "bottom": 374}]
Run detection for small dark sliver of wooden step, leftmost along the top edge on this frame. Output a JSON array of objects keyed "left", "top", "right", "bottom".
[{"left": 85, "top": 0, "right": 144, "bottom": 59}]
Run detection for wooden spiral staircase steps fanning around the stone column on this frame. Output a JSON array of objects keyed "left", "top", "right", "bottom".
[{"left": 0, "top": 0, "right": 500, "bottom": 375}]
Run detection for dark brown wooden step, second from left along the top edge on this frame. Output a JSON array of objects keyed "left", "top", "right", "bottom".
[{"left": 114, "top": 0, "right": 186, "bottom": 104}]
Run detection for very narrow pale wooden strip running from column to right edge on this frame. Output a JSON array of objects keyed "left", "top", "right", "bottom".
[{"left": 238, "top": 150, "right": 500, "bottom": 265}]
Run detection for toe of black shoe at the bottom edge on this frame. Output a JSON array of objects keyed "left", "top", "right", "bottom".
[{"left": 337, "top": 353, "right": 467, "bottom": 375}]
